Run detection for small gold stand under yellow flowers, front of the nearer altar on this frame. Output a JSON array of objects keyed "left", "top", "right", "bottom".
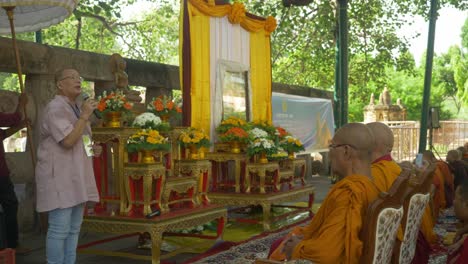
[{"left": 124, "top": 163, "right": 166, "bottom": 215}]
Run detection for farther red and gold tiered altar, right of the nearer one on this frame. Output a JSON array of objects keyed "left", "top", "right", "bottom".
[{"left": 206, "top": 152, "right": 314, "bottom": 231}]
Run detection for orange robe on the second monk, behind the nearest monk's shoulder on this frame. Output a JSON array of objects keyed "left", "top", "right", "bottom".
[{"left": 371, "top": 158, "right": 403, "bottom": 241}]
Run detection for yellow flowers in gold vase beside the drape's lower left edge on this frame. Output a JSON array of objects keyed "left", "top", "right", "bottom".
[{"left": 179, "top": 127, "right": 211, "bottom": 159}]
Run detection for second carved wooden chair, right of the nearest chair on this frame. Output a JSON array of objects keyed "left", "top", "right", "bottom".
[{"left": 392, "top": 164, "right": 436, "bottom": 264}]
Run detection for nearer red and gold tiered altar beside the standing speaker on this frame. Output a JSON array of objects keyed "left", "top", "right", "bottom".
[{"left": 83, "top": 128, "right": 227, "bottom": 264}]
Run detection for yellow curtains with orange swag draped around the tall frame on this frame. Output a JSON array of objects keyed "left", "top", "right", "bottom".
[{"left": 179, "top": 0, "right": 276, "bottom": 131}]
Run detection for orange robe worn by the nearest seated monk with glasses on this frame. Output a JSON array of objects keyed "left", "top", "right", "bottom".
[{"left": 270, "top": 175, "right": 379, "bottom": 264}]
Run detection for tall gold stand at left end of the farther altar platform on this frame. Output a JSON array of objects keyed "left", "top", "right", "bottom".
[{"left": 206, "top": 152, "right": 248, "bottom": 193}]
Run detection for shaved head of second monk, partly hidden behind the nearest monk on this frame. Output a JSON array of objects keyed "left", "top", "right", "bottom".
[{"left": 366, "top": 122, "right": 394, "bottom": 160}]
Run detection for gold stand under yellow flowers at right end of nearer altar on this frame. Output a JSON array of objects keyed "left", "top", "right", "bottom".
[{"left": 173, "top": 159, "right": 211, "bottom": 204}]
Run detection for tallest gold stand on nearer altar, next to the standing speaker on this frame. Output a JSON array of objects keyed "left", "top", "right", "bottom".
[{"left": 92, "top": 127, "right": 138, "bottom": 214}]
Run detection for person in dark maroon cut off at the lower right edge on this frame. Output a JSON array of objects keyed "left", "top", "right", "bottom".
[{"left": 447, "top": 182, "right": 468, "bottom": 264}]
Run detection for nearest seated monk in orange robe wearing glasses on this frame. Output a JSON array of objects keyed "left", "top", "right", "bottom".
[{"left": 270, "top": 123, "right": 379, "bottom": 263}]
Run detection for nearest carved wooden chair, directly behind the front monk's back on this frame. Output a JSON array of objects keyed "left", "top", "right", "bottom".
[{"left": 359, "top": 170, "right": 411, "bottom": 264}]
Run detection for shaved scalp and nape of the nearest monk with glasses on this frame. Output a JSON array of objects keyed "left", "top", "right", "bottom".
[{"left": 333, "top": 123, "right": 375, "bottom": 161}]
